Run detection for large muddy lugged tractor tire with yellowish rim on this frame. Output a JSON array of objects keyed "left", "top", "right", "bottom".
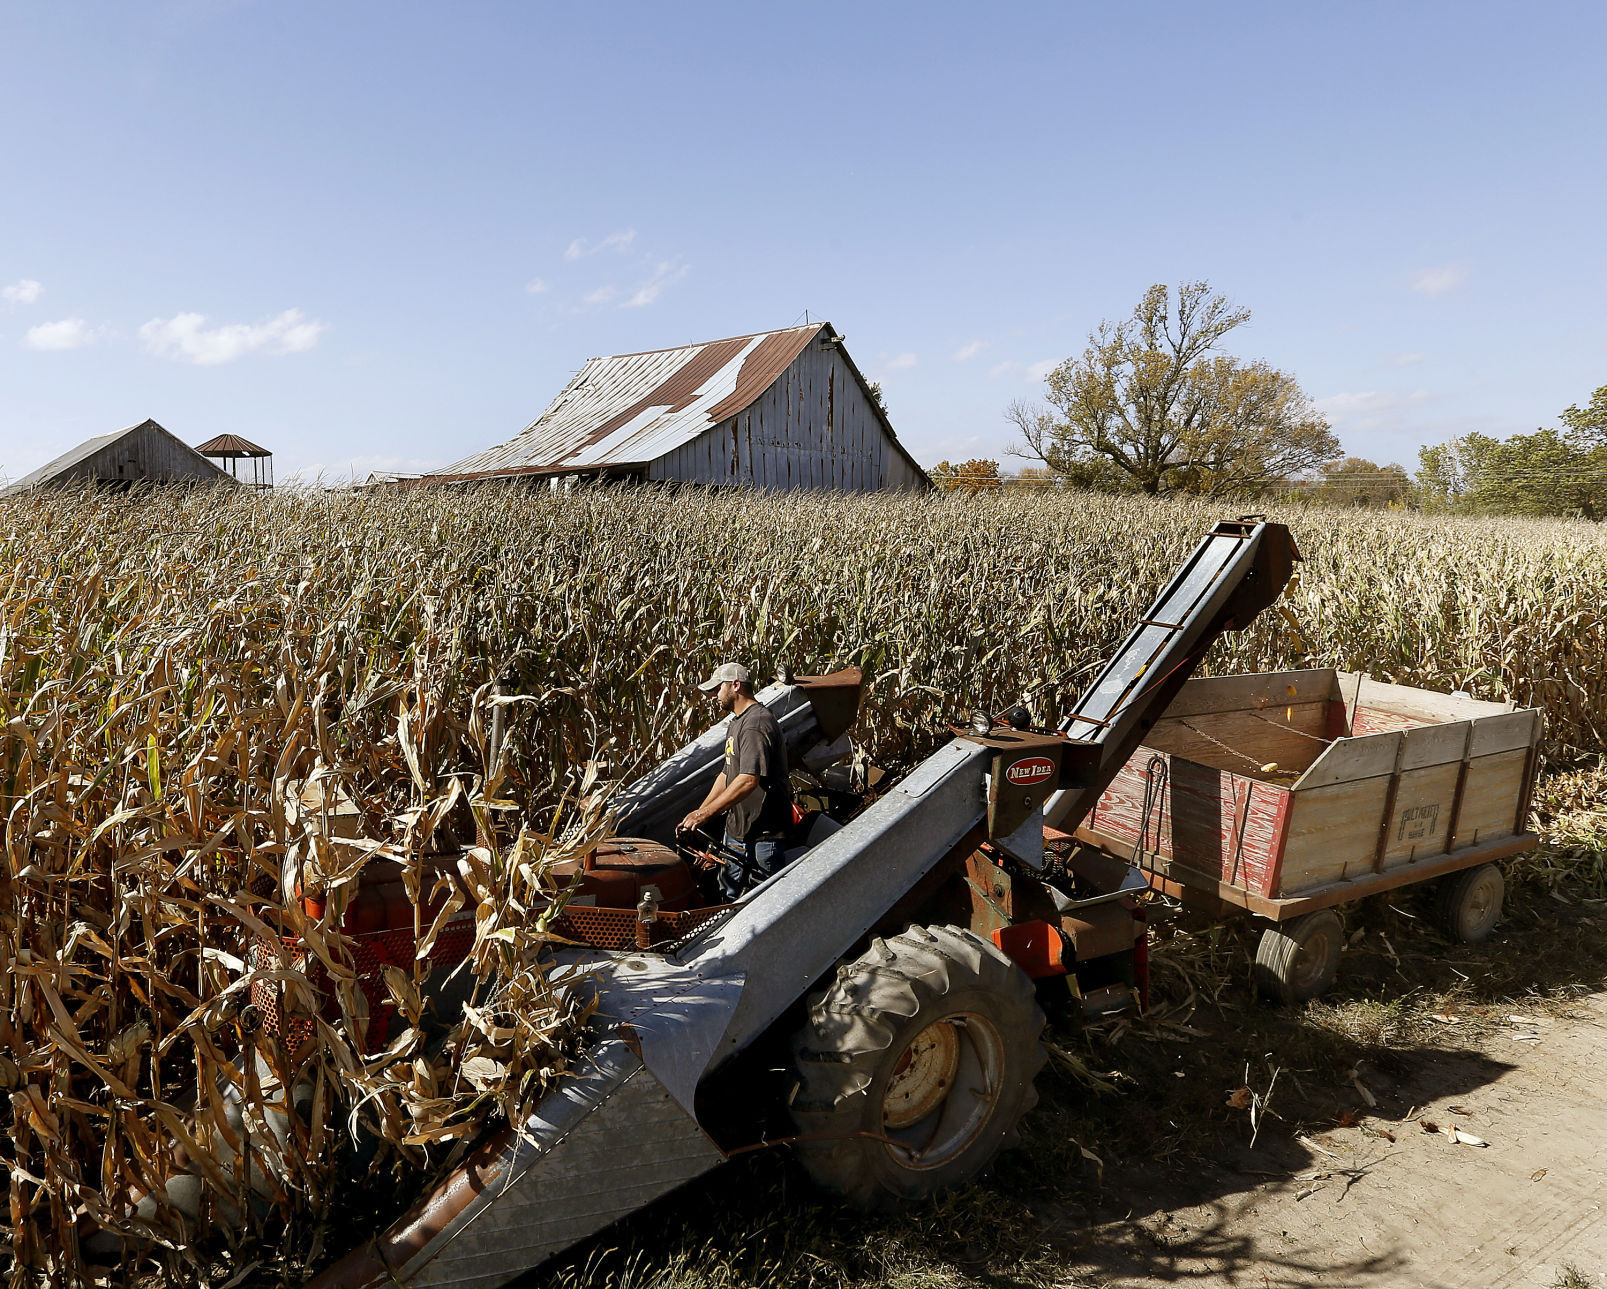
[{"left": 789, "top": 926, "right": 1045, "bottom": 1210}]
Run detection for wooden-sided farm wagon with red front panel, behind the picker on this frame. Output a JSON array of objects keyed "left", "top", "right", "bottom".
[{"left": 1077, "top": 670, "right": 1541, "bottom": 1001}]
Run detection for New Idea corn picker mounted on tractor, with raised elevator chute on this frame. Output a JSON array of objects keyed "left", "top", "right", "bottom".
[{"left": 250, "top": 519, "right": 1298, "bottom": 1289}]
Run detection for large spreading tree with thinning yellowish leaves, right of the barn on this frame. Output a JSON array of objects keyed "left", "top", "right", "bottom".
[{"left": 1006, "top": 281, "right": 1339, "bottom": 497}]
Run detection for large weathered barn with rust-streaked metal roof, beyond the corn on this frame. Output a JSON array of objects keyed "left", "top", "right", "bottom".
[{"left": 421, "top": 323, "right": 930, "bottom": 492}]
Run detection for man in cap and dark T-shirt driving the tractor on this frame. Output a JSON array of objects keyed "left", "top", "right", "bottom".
[{"left": 677, "top": 662, "right": 792, "bottom": 900}]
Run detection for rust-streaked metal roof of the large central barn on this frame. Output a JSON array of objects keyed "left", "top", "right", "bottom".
[{"left": 424, "top": 323, "right": 836, "bottom": 481}]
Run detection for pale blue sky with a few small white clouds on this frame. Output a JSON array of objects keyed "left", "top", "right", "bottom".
[{"left": 0, "top": 0, "right": 1607, "bottom": 479}]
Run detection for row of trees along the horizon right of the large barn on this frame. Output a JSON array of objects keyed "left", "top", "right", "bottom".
[{"left": 929, "top": 281, "right": 1607, "bottom": 521}]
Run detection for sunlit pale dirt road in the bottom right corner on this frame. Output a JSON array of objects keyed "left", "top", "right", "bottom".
[{"left": 1073, "top": 993, "right": 1607, "bottom": 1289}]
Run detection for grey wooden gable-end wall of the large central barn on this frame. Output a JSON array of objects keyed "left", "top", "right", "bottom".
[{"left": 648, "top": 342, "right": 926, "bottom": 492}]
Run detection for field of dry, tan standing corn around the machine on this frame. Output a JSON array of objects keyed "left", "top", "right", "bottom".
[{"left": 0, "top": 490, "right": 1607, "bottom": 1286}]
